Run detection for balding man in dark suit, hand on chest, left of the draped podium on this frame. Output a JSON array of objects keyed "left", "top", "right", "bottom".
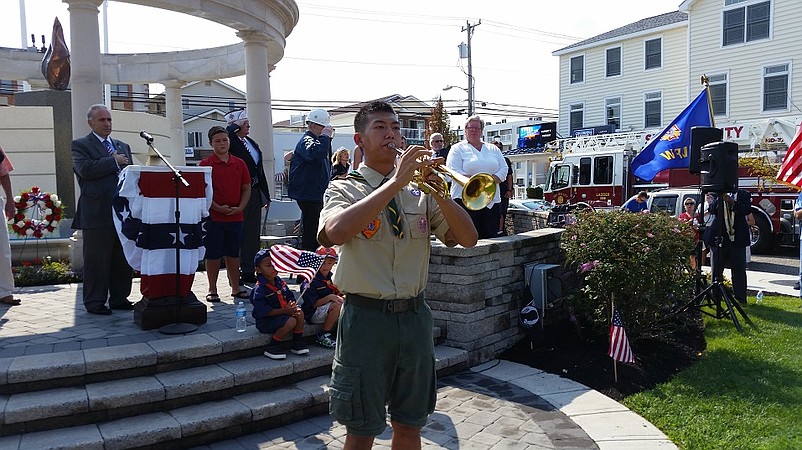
[{"left": 72, "top": 105, "right": 134, "bottom": 315}]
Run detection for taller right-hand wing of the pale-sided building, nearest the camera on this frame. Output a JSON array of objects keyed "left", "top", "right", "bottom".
[{"left": 679, "top": 0, "right": 802, "bottom": 147}]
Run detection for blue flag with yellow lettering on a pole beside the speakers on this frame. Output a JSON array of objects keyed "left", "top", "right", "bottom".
[{"left": 632, "top": 89, "right": 711, "bottom": 181}]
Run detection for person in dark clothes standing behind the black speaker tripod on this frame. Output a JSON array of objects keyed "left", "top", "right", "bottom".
[{"left": 704, "top": 189, "right": 752, "bottom": 304}]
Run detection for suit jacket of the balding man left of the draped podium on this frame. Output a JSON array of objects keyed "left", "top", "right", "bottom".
[{"left": 71, "top": 133, "right": 133, "bottom": 230}]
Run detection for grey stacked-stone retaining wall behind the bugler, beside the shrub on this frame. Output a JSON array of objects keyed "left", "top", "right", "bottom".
[{"left": 426, "top": 228, "right": 563, "bottom": 366}]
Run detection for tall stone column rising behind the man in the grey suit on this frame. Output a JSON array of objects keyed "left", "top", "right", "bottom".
[{"left": 63, "top": 0, "right": 103, "bottom": 138}]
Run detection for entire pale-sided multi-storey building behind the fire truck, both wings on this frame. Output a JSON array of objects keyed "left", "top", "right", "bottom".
[{"left": 553, "top": 0, "right": 802, "bottom": 149}]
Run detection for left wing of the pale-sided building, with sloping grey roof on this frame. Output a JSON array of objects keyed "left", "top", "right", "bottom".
[{"left": 553, "top": 11, "right": 695, "bottom": 137}]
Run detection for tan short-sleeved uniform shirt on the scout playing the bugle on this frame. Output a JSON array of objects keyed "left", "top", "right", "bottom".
[{"left": 318, "top": 165, "right": 455, "bottom": 300}]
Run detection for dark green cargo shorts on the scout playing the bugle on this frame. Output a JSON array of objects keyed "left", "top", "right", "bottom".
[{"left": 329, "top": 300, "right": 437, "bottom": 436}]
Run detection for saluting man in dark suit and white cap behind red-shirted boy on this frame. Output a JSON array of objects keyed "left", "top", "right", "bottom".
[{"left": 226, "top": 109, "right": 270, "bottom": 283}]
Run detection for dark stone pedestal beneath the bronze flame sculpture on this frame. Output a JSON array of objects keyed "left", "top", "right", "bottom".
[{"left": 14, "top": 89, "right": 76, "bottom": 217}]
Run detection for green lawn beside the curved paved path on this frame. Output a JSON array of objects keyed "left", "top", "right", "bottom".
[{"left": 624, "top": 296, "right": 802, "bottom": 449}]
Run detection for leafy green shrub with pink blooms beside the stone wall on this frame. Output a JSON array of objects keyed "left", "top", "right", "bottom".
[{"left": 561, "top": 211, "right": 694, "bottom": 335}]
